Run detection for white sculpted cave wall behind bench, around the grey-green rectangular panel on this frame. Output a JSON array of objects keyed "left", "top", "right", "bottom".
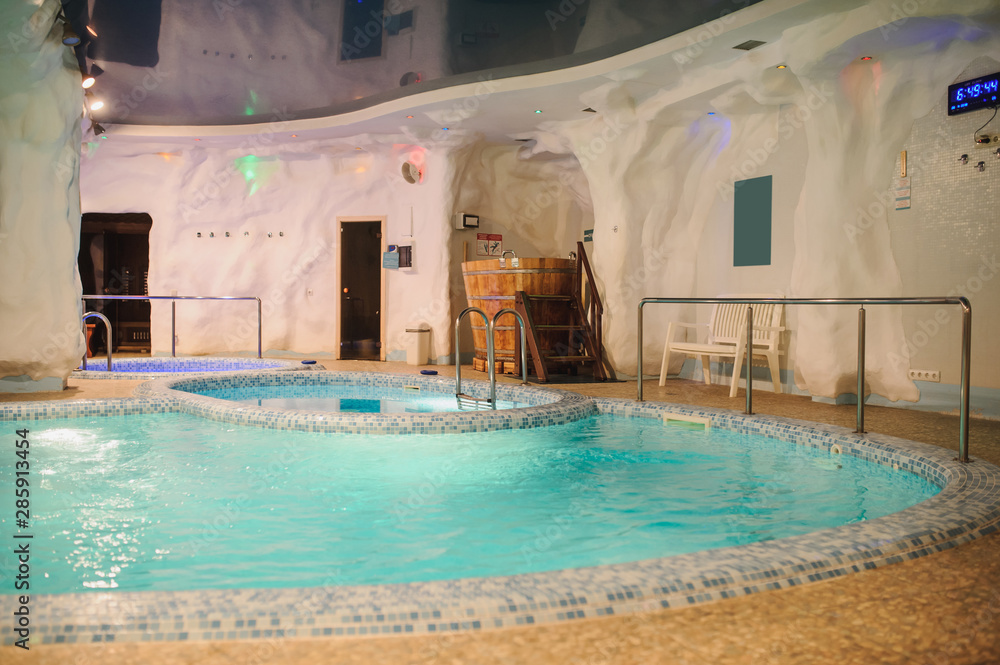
[{"left": 535, "top": 2, "right": 998, "bottom": 400}]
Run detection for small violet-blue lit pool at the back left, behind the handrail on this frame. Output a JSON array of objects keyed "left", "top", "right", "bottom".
[{"left": 70, "top": 356, "right": 314, "bottom": 380}]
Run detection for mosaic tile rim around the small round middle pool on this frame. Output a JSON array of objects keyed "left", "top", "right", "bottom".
[{"left": 135, "top": 371, "right": 596, "bottom": 434}]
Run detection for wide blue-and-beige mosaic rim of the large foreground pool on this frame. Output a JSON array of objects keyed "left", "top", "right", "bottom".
[{"left": 0, "top": 386, "right": 1000, "bottom": 645}]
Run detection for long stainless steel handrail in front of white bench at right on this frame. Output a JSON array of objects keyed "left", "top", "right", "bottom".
[{"left": 636, "top": 296, "right": 972, "bottom": 462}]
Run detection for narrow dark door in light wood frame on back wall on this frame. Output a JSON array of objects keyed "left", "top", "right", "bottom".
[{"left": 337, "top": 217, "right": 385, "bottom": 360}]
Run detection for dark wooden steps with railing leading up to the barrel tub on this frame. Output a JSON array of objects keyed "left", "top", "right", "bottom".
[{"left": 511, "top": 242, "right": 611, "bottom": 382}]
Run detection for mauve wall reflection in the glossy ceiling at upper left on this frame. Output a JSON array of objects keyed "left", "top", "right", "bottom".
[{"left": 98, "top": 0, "right": 448, "bottom": 121}]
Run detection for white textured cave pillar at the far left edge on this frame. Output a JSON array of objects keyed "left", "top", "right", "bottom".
[{"left": 0, "top": 0, "right": 84, "bottom": 391}]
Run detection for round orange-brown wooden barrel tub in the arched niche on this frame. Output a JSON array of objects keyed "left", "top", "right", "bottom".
[{"left": 462, "top": 258, "right": 576, "bottom": 373}]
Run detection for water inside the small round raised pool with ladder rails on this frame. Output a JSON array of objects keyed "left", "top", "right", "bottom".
[{"left": 188, "top": 384, "right": 528, "bottom": 413}]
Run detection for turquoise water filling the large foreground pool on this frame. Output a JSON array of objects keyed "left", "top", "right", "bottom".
[{"left": 0, "top": 414, "right": 938, "bottom": 593}]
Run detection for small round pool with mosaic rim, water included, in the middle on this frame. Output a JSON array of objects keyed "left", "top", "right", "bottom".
[{"left": 136, "top": 371, "right": 594, "bottom": 434}]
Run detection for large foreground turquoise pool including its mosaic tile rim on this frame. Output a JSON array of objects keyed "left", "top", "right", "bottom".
[{"left": 0, "top": 372, "right": 1000, "bottom": 644}]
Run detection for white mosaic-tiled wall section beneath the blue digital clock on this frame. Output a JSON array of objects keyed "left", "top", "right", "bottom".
[{"left": 887, "top": 57, "right": 1000, "bottom": 388}]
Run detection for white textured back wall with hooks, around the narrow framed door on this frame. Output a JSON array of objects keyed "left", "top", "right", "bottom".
[{"left": 81, "top": 134, "right": 451, "bottom": 358}]
